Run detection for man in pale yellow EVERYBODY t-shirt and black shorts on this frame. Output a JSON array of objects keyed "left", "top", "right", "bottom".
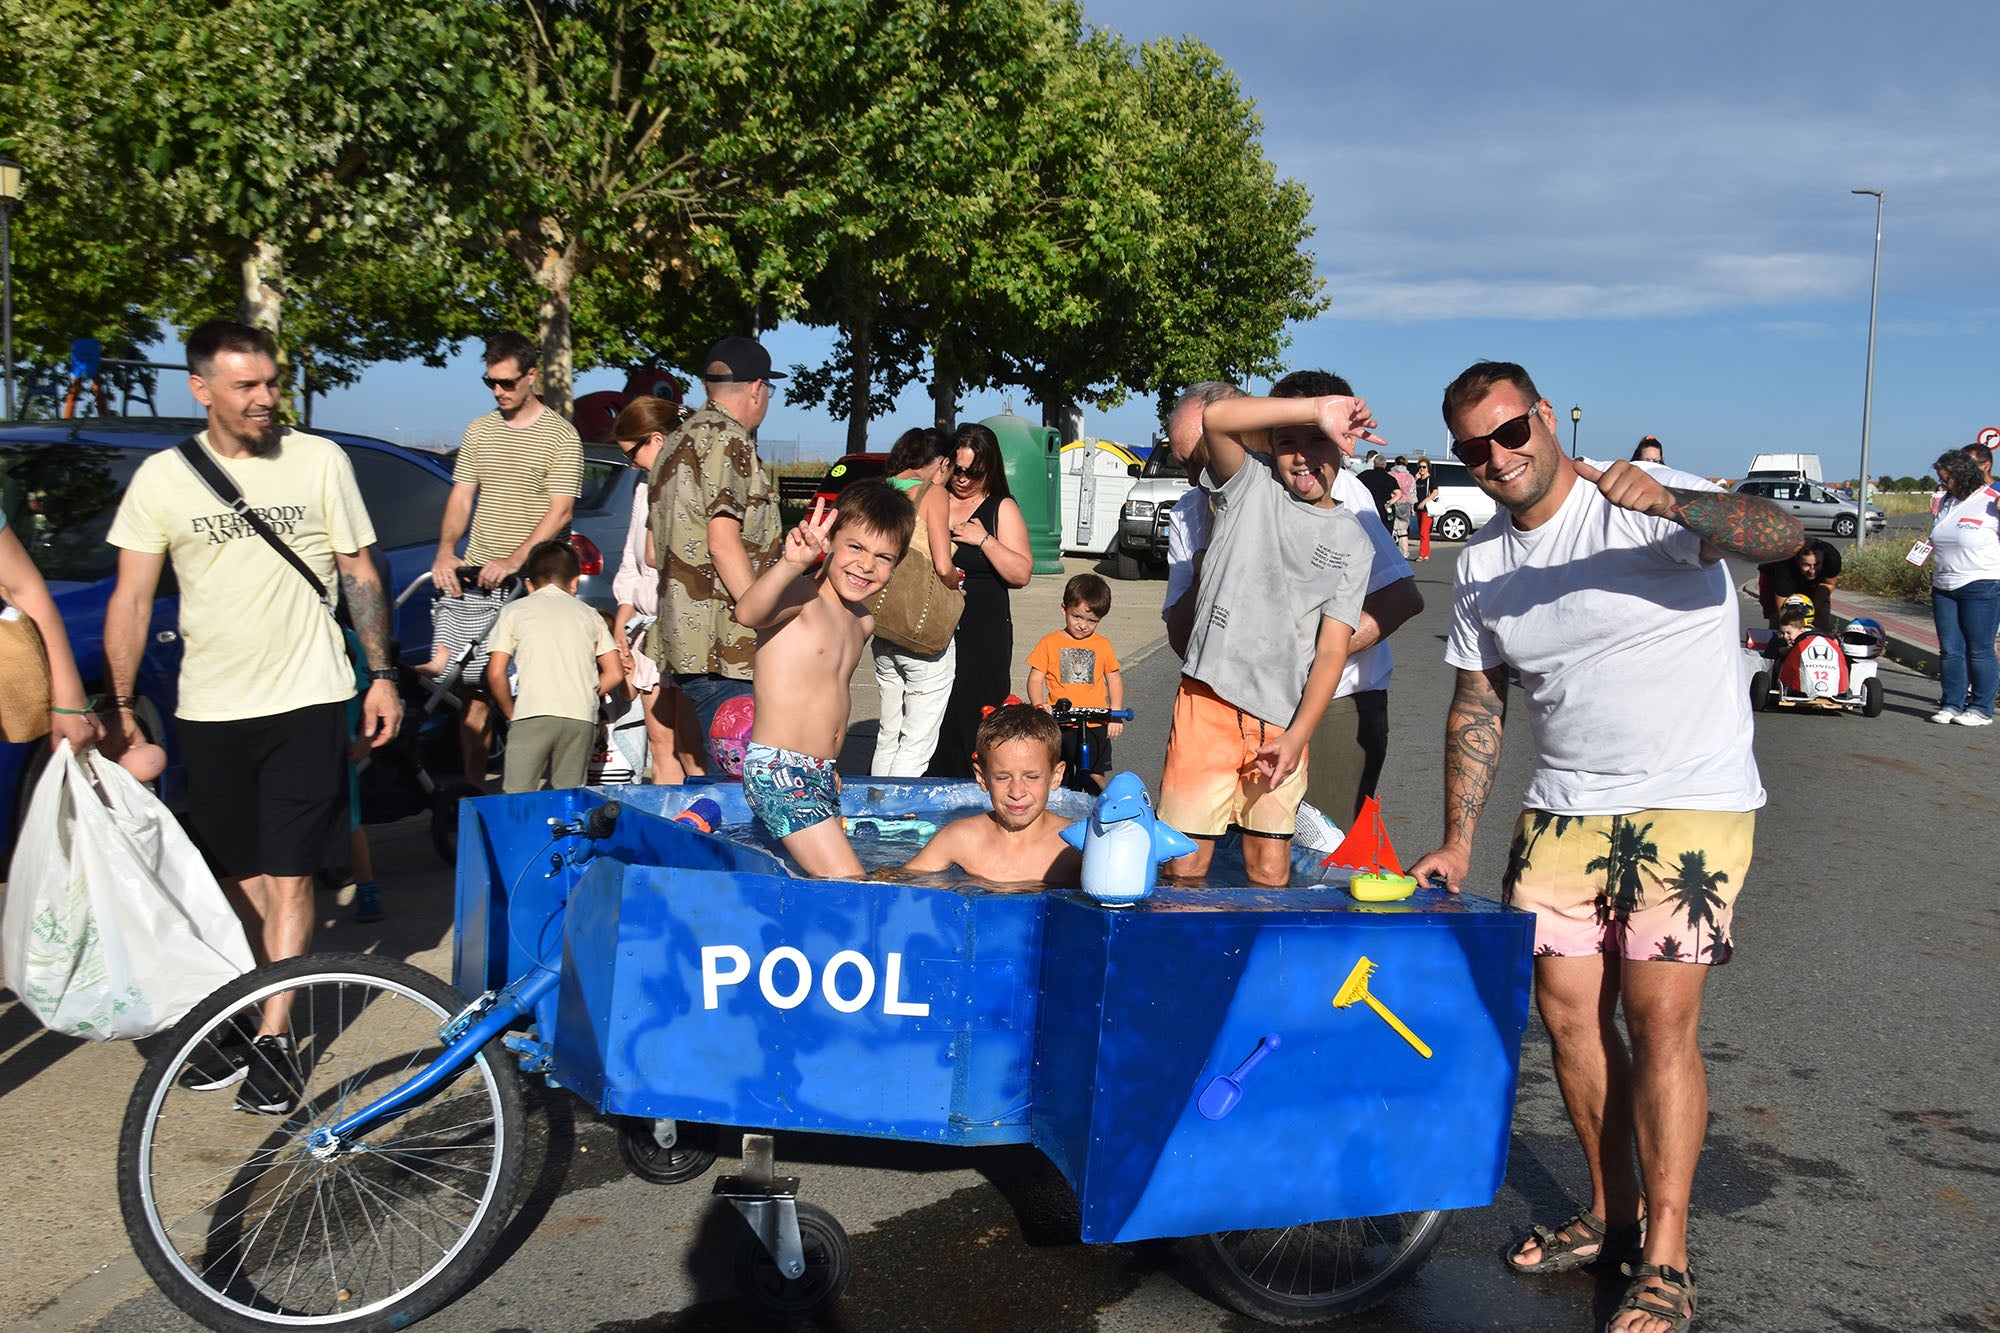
[{"left": 104, "top": 320, "right": 402, "bottom": 1115}]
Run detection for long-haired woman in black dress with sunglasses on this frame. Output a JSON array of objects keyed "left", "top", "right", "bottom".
[{"left": 928, "top": 426, "right": 1034, "bottom": 777}]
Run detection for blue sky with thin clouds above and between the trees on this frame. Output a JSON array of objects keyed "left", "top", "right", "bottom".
[{"left": 145, "top": 0, "right": 2000, "bottom": 476}]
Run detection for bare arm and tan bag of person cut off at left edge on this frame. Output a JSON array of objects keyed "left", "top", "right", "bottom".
[{"left": 0, "top": 512, "right": 104, "bottom": 751}]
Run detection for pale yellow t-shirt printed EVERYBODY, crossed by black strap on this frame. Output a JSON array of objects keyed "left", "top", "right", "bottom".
[{"left": 106, "top": 430, "right": 374, "bottom": 723}]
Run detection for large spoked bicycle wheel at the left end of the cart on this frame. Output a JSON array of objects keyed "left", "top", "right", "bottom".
[{"left": 118, "top": 953, "right": 526, "bottom": 1333}]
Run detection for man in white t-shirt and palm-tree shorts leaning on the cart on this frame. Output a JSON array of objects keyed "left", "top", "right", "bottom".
[{"left": 1412, "top": 362, "right": 1804, "bottom": 1333}]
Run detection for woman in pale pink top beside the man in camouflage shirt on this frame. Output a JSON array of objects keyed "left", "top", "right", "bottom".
[{"left": 612, "top": 396, "right": 706, "bottom": 783}]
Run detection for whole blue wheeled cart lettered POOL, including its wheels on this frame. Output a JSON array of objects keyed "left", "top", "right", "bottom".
[{"left": 118, "top": 779, "right": 1532, "bottom": 1329}]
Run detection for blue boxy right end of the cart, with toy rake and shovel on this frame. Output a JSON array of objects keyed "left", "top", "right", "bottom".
[{"left": 1034, "top": 889, "right": 1532, "bottom": 1241}]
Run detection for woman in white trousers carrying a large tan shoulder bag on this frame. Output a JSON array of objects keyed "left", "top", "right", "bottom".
[{"left": 868, "top": 426, "right": 966, "bottom": 777}]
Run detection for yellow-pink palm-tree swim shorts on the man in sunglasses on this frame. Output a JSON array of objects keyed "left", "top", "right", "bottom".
[{"left": 1500, "top": 811, "right": 1756, "bottom": 965}]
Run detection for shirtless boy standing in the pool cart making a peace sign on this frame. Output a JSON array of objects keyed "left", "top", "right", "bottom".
[{"left": 736, "top": 482, "right": 916, "bottom": 879}]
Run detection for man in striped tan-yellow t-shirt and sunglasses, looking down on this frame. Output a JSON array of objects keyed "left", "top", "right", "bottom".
[{"left": 430, "top": 332, "right": 584, "bottom": 783}]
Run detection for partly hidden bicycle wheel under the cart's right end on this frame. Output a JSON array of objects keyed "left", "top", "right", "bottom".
[{"left": 1184, "top": 1209, "right": 1446, "bottom": 1325}]
